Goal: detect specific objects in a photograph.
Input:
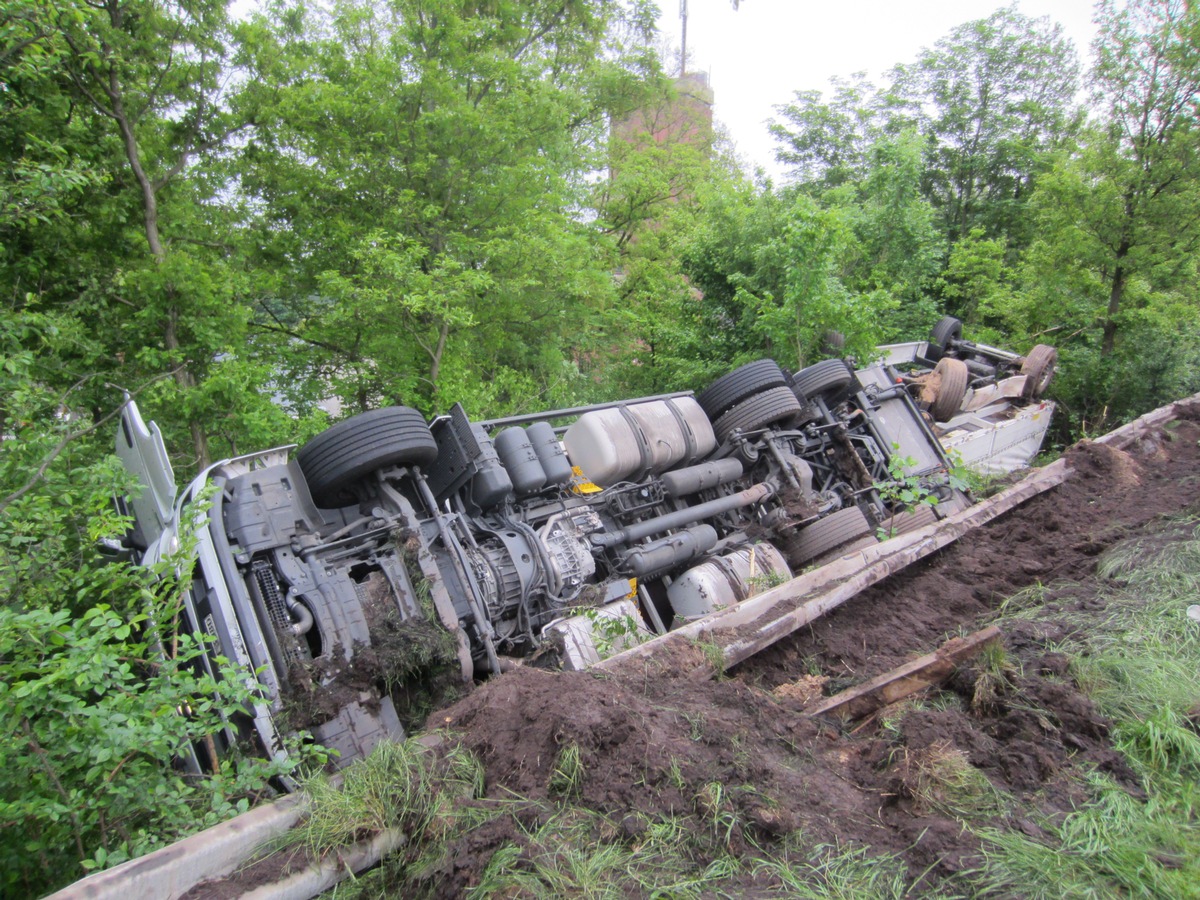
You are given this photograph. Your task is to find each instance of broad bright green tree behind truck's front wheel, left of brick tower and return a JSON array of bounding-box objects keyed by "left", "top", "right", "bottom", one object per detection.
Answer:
[{"left": 242, "top": 0, "right": 662, "bottom": 420}]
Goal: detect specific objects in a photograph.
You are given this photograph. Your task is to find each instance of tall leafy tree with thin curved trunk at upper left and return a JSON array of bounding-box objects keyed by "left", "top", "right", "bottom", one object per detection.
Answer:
[{"left": 0, "top": 0, "right": 295, "bottom": 466}]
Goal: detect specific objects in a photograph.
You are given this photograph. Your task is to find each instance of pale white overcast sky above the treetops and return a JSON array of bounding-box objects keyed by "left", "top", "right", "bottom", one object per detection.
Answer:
[{"left": 659, "top": 0, "right": 1096, "bottom": 181}]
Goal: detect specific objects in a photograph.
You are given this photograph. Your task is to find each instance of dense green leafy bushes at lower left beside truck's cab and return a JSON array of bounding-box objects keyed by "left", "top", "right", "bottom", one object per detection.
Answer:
[{"left": 0, "top": 472, "right": 319, "bottom": 895}]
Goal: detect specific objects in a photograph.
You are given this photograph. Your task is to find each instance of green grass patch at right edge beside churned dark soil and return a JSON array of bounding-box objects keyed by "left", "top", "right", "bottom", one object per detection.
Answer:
[{"left": 973, "top": 520, "right": 1200, "bottom": 900}]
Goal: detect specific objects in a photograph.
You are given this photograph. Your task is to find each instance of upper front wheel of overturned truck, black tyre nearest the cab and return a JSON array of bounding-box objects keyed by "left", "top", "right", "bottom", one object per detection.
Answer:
[{"left": 296, "top": 407, "right": 438, "bottom": 509}]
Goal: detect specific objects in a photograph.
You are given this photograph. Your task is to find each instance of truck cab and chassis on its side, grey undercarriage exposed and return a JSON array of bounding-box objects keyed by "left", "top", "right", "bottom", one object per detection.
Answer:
[{"left": 118, "top": 340, "right": 1051, "bottom": 772}]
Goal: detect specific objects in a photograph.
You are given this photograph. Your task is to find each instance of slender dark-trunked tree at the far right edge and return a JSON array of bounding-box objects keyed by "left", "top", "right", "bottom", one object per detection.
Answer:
[{"left": 1008, "top": 0, "right": 1200, "bottom": 428}]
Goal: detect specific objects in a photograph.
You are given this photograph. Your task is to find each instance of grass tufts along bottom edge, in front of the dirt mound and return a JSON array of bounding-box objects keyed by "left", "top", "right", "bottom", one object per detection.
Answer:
[{"left": 302, "top": 743, "right": 948, "bottom": 900}]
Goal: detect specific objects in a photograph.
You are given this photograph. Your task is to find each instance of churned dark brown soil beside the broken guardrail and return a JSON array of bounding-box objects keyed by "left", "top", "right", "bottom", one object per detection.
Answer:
[{"left": 428, "top": 409, "right": 1200, "bottom": 896}]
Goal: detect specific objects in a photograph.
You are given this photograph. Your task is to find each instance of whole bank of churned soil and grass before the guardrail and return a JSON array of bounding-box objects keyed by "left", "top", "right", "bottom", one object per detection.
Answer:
[{"left": 187, "top": 412, "right": 1200, "bottom": 898}]
